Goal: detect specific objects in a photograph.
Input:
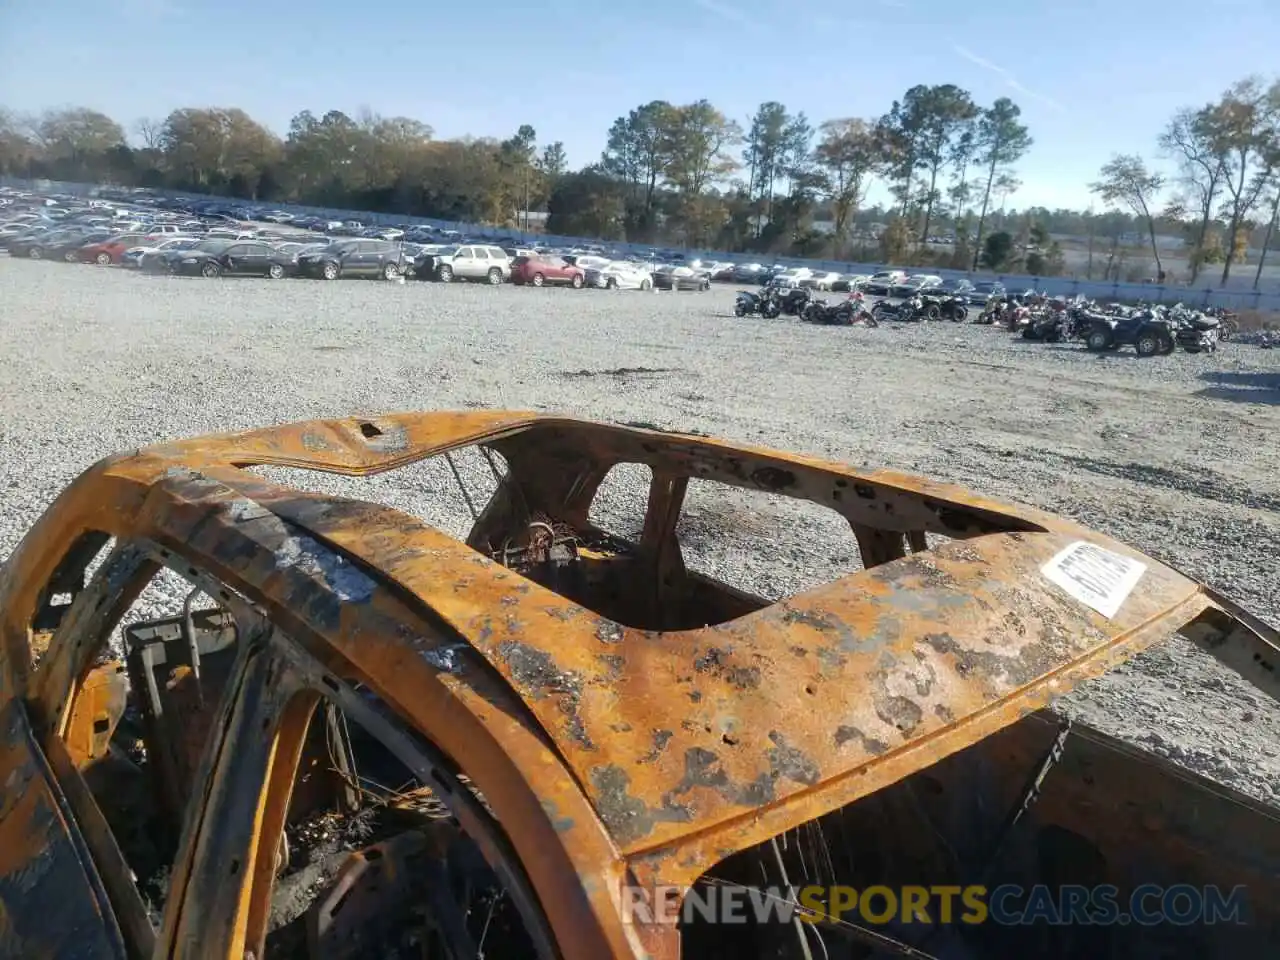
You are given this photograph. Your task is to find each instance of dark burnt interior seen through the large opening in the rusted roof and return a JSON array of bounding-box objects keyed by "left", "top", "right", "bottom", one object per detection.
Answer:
[{"left": 466, "top": 426, "right": 1038, "bottom": 631}]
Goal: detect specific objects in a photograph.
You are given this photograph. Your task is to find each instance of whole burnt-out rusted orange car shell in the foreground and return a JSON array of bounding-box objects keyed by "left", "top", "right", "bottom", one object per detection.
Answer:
[{"left": 0, "top": 412, "right": 1280, "bottom": 960}]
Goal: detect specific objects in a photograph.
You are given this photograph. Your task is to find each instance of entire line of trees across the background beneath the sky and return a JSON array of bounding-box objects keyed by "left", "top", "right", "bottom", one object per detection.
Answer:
[{"left": 0, "top": 77, "right": 1280, "bottom": 280}]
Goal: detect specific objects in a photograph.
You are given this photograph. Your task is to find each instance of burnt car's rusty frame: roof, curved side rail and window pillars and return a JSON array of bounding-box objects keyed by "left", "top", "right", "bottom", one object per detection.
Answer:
[{"left": 0, "top": 412, "right": 1280, "bottom": 960}]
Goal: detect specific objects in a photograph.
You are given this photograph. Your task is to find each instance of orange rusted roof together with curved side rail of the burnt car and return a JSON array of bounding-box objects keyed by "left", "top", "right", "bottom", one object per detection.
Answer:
[{"left": 0, "top": 412, "right": 1269, "bottom": 957}]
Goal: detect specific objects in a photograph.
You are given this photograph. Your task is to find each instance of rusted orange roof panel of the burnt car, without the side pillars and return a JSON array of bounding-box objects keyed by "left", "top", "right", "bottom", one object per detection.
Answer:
[{"left": 0, "top": 412, "right": 1276, "bottom": 906}]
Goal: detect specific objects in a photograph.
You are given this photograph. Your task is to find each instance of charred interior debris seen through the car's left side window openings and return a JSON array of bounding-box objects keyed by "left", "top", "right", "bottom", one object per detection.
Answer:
[{"left": 42, "top": 539, "right": 538, "bottom": 960}]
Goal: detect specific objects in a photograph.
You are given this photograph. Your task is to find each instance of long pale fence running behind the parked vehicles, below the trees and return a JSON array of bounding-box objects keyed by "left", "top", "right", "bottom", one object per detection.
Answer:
[{"left": 0, "top": 177, "right": 1280, "bottom": 312}]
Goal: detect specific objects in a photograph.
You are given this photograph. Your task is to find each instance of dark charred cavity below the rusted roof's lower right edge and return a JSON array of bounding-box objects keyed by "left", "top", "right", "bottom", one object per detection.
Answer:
[{"left": 681, "top": 713, "right": 1280, "bottom": 960}]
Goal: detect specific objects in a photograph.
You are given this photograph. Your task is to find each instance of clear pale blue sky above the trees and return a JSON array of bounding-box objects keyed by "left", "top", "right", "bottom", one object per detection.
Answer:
[{"left": 0, "top": 0, "right": 1280, "bottom": 206}]
